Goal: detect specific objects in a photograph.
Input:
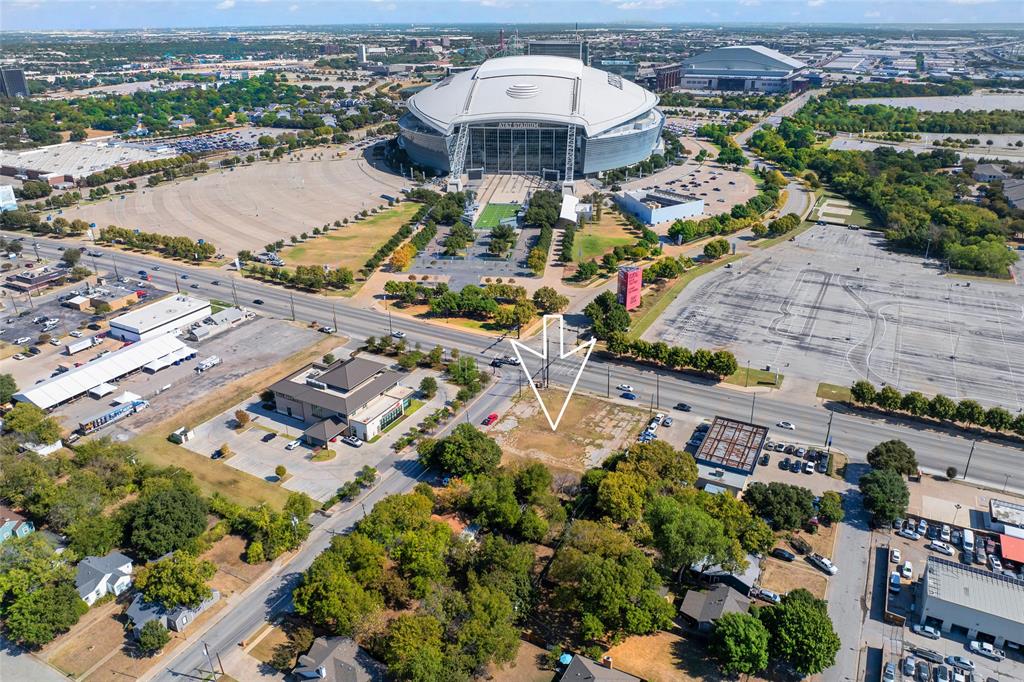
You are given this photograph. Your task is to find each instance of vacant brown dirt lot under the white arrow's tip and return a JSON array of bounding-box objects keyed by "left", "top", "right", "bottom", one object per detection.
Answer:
[{"left": 489, "top": 386, "right": 645, "bottom": 473}]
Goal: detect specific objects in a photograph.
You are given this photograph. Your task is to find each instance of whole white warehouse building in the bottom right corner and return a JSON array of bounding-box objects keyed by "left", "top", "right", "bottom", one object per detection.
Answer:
[{"left": 919, "top": 556, "right": 1024, "bottom": 648}]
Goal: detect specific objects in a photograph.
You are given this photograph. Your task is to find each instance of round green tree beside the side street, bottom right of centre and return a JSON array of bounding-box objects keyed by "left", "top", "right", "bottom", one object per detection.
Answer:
[{"left": 757, "top": 588, "right": 842, "bottom": 675}]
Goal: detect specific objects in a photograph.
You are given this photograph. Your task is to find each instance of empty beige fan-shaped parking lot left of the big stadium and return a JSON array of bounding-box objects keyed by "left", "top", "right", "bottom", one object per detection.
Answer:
[{"left": 65, "top": 147, "right": 410, "bottom": 255}]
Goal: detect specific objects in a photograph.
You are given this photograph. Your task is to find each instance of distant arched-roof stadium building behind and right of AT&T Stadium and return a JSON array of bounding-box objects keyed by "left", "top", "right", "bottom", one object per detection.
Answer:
[{"left": 680, "top": 45, "right": 807, "bottom": 92}]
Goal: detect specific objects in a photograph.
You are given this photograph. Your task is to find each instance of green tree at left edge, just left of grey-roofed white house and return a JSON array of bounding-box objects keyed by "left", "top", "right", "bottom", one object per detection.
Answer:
[{"left": 4, "top": 580, "right": 89, "bottom": 648}]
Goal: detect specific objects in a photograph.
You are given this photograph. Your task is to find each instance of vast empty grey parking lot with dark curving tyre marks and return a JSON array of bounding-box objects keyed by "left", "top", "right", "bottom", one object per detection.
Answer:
[{"left": 645, "top": 226, "right": 1024, "bottom": 412}]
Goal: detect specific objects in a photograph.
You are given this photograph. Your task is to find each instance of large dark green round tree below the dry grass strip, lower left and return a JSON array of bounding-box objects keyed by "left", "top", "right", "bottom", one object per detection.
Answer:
[{"left": 122, "top": 487, "right": 206, "bottom": 558}]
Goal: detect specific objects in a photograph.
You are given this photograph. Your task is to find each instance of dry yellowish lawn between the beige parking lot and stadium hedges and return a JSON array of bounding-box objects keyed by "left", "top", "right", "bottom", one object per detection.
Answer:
[{"left": 282, "top": 202, "right": 420, "bottom": 271}]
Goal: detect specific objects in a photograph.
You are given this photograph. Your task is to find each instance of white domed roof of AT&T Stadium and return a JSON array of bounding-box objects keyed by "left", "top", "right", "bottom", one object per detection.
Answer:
[{"left": 409, "top": 55, "right": 657, "bottom": 137}]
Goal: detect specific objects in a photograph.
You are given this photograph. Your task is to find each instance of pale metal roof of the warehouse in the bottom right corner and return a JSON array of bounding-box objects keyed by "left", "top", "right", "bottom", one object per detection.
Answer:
[{"left": 925, "top": 557, "right": 1024, "bottom": 623}]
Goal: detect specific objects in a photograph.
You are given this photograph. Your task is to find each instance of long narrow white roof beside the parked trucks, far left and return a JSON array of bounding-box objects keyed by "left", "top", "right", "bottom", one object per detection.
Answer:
[{"left": 14, "top": 334, "right": 192, "bottom": 410}]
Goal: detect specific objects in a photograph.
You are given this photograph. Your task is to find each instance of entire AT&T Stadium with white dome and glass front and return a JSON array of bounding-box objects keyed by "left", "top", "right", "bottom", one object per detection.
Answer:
[{"left": 398, "top": 56, "right": 665, "bottom": 182}]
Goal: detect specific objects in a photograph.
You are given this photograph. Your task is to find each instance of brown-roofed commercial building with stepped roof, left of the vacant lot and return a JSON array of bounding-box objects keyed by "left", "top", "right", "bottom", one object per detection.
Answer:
[{"left": 270, "top": 356, "right": 413, "bottom": 445}]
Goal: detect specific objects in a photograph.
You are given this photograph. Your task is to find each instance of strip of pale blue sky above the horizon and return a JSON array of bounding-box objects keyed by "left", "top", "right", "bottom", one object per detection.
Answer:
[{"left": 0, "top": 0, "right": 1024, "bottom": 31}]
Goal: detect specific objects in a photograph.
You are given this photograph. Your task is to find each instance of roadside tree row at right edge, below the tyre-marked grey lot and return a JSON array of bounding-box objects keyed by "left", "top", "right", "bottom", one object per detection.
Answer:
[{"left": 850, "top": 380, "right": 1024, "bottom": 436}]
